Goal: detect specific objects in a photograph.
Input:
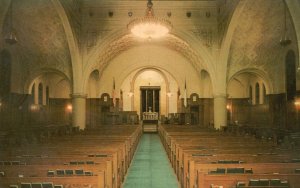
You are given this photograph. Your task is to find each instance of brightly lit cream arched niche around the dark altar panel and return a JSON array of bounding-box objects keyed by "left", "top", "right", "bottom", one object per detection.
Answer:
[{"left": 116, "top": 66, "right": 180, "bottom": 115}]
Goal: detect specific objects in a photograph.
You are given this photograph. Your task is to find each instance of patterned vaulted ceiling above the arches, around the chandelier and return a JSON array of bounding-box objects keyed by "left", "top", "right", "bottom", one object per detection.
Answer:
[{"left": 0, "top": 0, "right": 296, "bottom": 93}]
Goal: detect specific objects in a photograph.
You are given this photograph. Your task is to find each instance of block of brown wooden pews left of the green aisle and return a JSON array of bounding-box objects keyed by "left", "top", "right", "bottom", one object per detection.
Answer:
[{"left": 0, "top": 125, "right": 142, "bottom": 188}]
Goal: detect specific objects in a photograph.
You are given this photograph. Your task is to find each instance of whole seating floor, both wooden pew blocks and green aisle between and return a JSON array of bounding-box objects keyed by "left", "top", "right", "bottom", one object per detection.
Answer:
[{"left": 0, "top": 124, "right": 300, "bottom": 188}]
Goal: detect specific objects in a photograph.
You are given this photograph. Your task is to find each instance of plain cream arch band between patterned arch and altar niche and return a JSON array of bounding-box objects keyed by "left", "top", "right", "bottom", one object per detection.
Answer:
[{"left": 84, "top": 44, "right": 200, "bottom": 97}]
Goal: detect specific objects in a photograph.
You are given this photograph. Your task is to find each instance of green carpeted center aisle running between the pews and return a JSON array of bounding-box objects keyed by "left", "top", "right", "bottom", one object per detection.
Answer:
[{"left": 123, "top": 134, "right": 179, "bottom": 188}]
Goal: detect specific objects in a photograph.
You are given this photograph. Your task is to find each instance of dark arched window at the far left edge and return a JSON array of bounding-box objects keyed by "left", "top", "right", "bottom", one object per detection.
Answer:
[{"left": 0, "top": 50, "right": 11, "bottom": 99}]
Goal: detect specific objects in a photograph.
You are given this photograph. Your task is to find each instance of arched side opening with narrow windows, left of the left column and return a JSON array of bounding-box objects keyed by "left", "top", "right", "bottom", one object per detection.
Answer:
[{"left": 28, "top": 72, "right": 72, "bottom": 125}]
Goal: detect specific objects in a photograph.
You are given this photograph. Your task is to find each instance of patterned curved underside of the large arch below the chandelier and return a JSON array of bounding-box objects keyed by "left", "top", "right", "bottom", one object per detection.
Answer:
[{"left": 84, "top": 30, "right": 215, "bottom": 90}]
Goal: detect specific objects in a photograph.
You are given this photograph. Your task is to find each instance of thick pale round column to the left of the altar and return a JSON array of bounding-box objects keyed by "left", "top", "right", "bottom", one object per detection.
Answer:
[{"left": 72, "top": 93, "right": 87, "bottom": 130}]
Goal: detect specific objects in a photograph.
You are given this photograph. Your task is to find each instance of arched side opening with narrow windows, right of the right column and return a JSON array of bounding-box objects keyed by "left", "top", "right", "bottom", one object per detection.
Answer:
[{"left": 227, "top": 70, "right": 270, "bottom": 126}]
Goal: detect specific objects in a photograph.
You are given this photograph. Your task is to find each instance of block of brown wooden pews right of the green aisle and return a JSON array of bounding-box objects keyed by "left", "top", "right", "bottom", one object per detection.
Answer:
[{"left": 158, "top": 125, "right": 300, "bottom": 188}]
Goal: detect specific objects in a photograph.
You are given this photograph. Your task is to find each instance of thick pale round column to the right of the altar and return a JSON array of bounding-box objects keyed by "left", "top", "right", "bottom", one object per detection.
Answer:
[{"left": 214, "top": 94, "right": 227, "bottom": 130}]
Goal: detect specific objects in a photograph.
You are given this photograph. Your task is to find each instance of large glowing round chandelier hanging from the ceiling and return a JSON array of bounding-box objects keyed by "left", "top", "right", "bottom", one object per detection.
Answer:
[{"left": 127, "top": 0, "right": 172, "bottom": 40}]
